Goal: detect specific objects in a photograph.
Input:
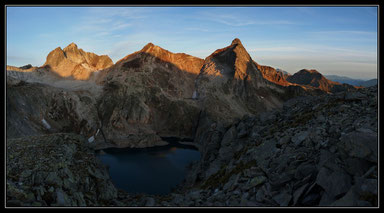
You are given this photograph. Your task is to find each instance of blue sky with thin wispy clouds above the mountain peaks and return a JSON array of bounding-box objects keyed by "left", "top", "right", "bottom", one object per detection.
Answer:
[{"left": 6, "top": 7, "right": 378, "bottom": 79}]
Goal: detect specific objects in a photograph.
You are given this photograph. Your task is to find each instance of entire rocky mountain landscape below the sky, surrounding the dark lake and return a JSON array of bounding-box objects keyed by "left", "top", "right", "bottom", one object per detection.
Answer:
[{"left": 6, "top": 39, "right": 379, "bottom": 207}]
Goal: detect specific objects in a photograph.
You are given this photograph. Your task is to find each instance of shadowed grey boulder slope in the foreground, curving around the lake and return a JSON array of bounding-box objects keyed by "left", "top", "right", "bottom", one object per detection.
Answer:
[{"left": 7, "top": 86, "right": 378, "bottom": 206}]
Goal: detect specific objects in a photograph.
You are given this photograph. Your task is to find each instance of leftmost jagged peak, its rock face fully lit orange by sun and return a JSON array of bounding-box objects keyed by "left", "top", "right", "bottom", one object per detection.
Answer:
[{"left": 43, "top": 43, "right": 113, "bottom": 80}]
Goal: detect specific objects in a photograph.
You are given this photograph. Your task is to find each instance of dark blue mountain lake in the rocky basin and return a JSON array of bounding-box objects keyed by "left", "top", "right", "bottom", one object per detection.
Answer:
[{"left": 97, "top": 142, "right": 200, "bottom": 194}]
